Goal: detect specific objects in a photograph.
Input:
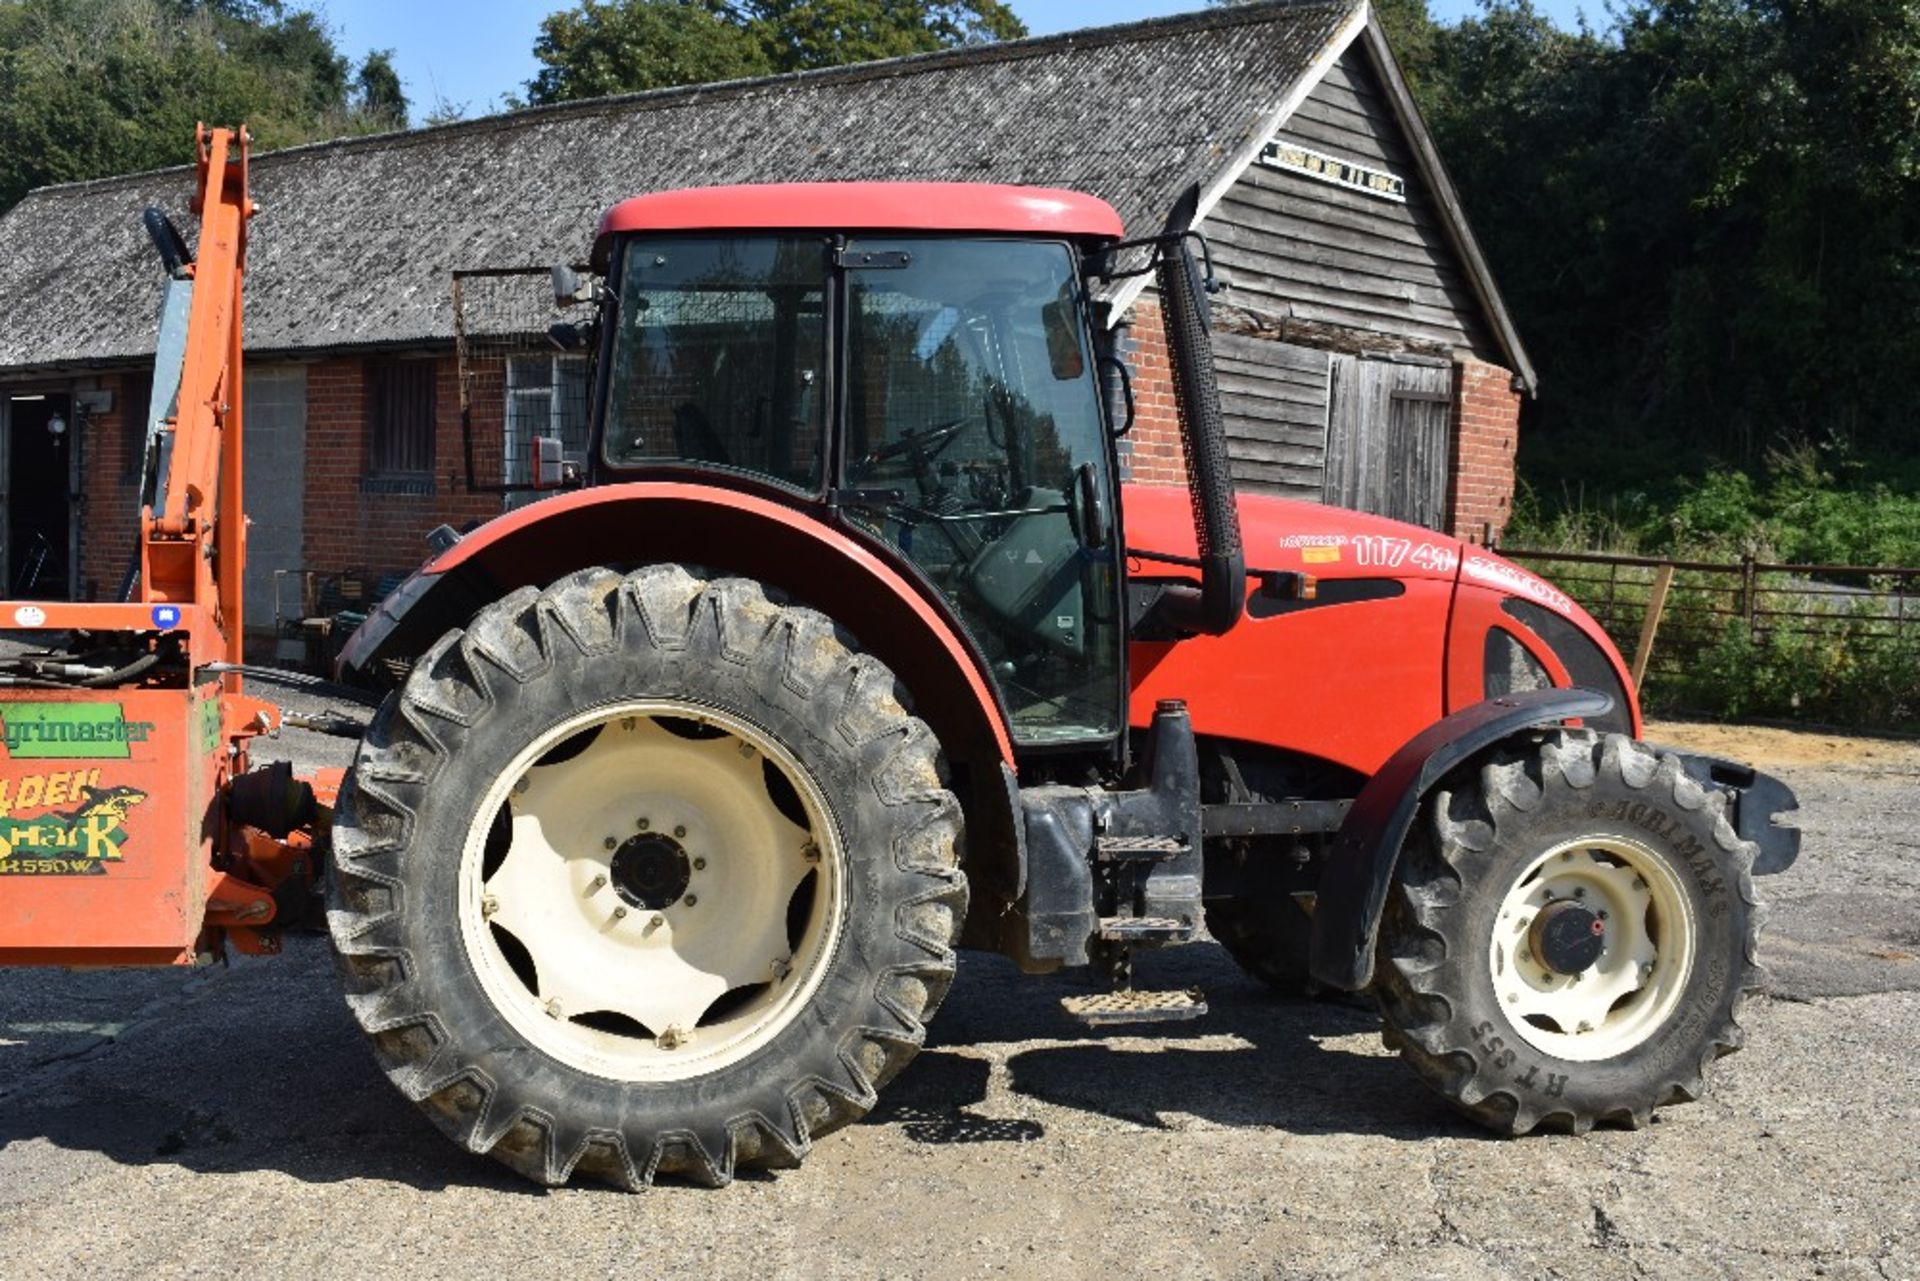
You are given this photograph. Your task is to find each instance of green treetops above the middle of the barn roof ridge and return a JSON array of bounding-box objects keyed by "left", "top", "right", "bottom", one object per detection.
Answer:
[{"left": 526, "top": 0, "right": 1027, "bottom": 104}]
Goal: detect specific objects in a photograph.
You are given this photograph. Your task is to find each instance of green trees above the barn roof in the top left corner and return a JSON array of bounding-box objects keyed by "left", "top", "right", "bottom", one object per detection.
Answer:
[{"left": 0, "top": 0, "right": 407, "bottom": 211}]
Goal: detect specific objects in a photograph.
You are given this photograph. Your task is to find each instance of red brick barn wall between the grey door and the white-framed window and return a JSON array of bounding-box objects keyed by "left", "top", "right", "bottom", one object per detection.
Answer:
[{"left": 301, "top": 347, "right": 501, "bottom": 574}]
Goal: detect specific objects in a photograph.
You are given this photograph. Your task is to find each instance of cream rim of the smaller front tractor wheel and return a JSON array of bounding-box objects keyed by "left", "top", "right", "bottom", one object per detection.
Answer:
[{"left": 1488, "top": 835, "right": 1697, "bottom": 1062}]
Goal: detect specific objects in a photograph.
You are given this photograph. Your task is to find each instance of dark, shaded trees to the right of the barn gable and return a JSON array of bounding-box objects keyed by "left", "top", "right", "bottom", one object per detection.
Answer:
[{"left": 1423, "top": 0, "right": 1920, "bottom": 492}]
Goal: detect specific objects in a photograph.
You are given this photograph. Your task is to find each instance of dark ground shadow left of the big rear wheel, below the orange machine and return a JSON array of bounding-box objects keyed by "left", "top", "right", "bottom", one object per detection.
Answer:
[{"left": 0, "top": 939, "right": 541, "bottom": 1196}]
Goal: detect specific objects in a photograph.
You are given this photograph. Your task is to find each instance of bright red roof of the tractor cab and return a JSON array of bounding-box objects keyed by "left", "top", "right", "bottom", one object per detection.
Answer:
[{"left": 593, "top": 182, "right": 1125, "bottom": 265}]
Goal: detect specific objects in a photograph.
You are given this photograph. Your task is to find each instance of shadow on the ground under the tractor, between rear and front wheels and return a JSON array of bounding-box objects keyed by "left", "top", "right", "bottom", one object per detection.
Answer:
[{"left": 868, "top": 945, "right": 1486, "bottom": 1145}]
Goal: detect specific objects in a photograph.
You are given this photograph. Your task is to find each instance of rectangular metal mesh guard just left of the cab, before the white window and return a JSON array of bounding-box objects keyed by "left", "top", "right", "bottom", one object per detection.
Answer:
[{"left": 453, "top": 267, "right": 591, "bottom": 507}]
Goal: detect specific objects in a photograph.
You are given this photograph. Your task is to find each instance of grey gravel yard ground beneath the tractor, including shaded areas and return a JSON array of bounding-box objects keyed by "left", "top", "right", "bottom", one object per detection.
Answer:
[{"left": 0, "top": 706, "right": 1920, "bottom": 1279}]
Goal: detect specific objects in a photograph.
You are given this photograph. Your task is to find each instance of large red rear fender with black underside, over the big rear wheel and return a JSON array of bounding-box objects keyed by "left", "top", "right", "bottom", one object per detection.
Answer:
[{"left": 340, "top": 480, "right": 1014, "bottom": 810}]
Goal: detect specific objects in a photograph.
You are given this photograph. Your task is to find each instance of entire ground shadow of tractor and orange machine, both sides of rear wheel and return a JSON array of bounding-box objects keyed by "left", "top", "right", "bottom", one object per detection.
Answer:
[{"left": 0, "top": 939, "right": 1478, "bottom": 1196}]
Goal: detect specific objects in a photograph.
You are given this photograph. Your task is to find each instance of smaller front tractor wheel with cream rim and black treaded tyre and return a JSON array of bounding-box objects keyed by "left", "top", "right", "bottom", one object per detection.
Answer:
[{"left": 1377, "top": 730, "right": 1763, "bottom": 1135}]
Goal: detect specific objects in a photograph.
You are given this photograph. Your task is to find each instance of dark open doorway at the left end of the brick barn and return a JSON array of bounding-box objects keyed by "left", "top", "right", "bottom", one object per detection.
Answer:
[{"left": 0, "top": 392, "right": 75, "bottom": 601}]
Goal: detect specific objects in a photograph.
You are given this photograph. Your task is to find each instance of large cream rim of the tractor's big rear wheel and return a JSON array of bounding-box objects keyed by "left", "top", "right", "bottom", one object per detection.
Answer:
[{"left": 459, "top": 699, "right": 845, "bottom": 1081}]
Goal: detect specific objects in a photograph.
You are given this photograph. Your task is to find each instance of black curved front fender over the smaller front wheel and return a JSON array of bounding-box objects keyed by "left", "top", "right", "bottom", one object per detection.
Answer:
[{"left": 1309, "top": 689, "right": 1613, "bottom": 991}]
